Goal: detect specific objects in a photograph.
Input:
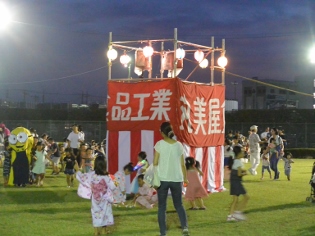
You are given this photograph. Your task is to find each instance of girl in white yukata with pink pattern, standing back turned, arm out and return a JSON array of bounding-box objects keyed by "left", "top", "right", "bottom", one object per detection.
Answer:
[{"left": 74, "top": 156, "right": 115, "bottom": 235}]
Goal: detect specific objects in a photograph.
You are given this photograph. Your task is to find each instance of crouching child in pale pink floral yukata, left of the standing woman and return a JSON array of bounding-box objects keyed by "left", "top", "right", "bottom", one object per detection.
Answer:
[{"left": 135, "top": 175, "right": 158, "bottom": 209}]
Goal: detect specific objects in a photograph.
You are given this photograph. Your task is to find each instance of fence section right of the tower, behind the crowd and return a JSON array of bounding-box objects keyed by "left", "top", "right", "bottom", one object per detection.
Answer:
[{"left": 225, "top": 122, "right": 315, "bottom": 148}]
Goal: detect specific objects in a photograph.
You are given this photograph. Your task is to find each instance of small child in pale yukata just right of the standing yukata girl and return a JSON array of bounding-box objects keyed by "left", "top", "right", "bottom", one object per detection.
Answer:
[{"left": 113, "top": 162, "right": 133, "bottom": 205}]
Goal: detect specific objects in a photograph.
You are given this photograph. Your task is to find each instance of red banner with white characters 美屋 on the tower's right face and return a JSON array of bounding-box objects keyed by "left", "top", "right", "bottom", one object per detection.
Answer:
[{"left": 173, "top": 80, "right": 225, "bottom": 147}]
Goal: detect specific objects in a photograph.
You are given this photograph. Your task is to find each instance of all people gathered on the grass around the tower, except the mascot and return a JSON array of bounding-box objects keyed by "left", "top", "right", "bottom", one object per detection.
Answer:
[{"left": 0, "top": 122, "right": 293, "bottom": 235}]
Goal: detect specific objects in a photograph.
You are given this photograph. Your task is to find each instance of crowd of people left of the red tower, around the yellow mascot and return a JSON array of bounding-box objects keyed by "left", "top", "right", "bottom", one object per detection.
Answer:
[{"left": 0, "top": 123, "right": 105, "bottom": 188}]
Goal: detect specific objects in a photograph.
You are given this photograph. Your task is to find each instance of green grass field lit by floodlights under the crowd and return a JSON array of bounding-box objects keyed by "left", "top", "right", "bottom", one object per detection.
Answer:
[{"left": 0, "top": 159, "right": 315, "bottom": 236}]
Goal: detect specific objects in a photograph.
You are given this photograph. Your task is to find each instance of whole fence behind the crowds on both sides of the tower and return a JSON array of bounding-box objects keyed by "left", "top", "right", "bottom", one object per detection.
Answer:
[{"left": 3, "top": 120, "right": 315, "bottom": 148}]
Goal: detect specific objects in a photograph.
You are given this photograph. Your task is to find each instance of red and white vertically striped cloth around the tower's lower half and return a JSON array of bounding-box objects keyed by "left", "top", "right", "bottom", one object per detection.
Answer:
[{"left": 106, "top": 130, "right": 224, "bottom": 192}]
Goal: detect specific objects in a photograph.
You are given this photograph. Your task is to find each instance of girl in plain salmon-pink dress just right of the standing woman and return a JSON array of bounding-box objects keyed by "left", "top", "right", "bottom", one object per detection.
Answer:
[{"left": 185, "top": 157, "right": 208, "bottom": 210}]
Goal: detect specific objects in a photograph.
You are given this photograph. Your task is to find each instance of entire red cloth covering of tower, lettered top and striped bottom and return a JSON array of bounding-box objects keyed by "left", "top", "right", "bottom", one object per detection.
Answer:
[{"left": 106, "top": 78, "right": 225, "bottom": 192}]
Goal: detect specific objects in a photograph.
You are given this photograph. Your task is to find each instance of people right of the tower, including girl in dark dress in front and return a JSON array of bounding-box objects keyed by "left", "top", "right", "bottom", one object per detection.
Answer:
[{"left": 224, "top": 125, "right": 294, "bottom": 221}]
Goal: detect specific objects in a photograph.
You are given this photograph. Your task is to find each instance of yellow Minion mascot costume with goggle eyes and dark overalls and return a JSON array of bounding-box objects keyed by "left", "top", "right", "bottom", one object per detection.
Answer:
[{"left": 8, "top": 127, "right": 34, "bottom": 187}]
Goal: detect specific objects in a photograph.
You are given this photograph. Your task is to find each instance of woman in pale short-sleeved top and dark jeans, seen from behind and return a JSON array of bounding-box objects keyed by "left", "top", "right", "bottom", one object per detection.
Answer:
[{"left": 153, "top": 122, "right": 189, "bottom": 235}]
